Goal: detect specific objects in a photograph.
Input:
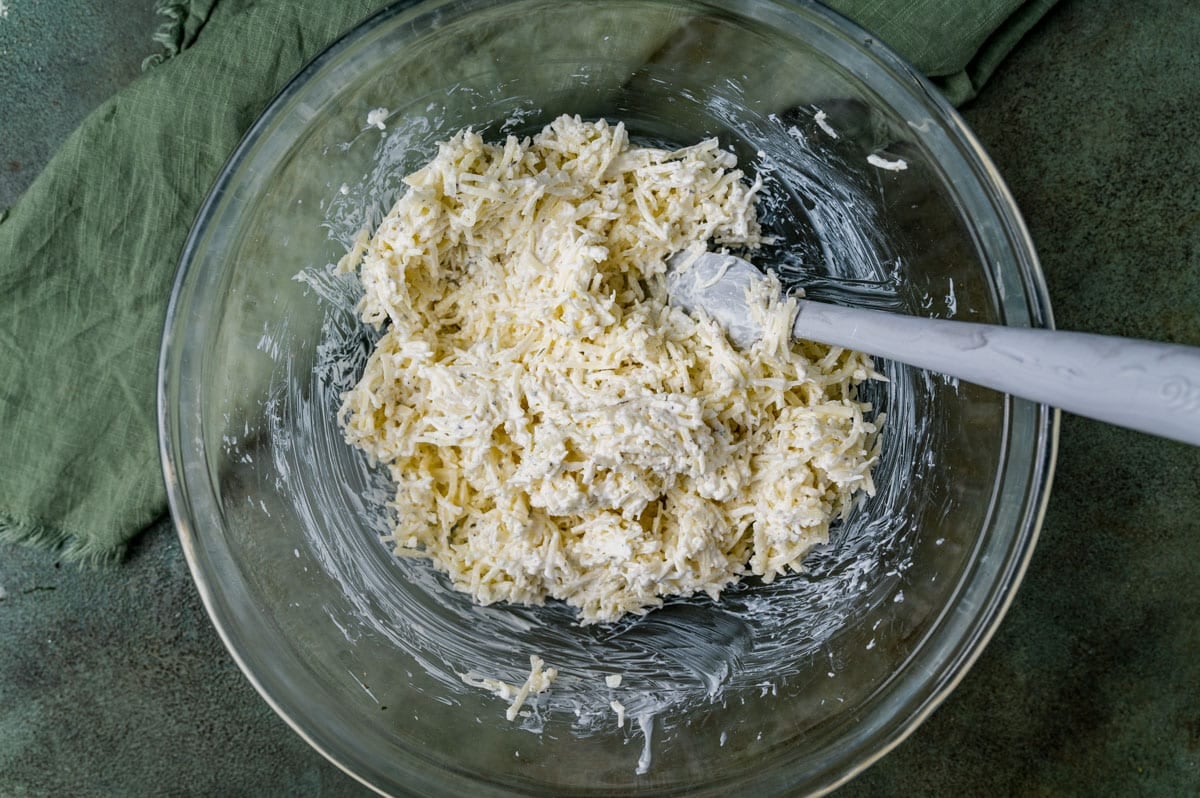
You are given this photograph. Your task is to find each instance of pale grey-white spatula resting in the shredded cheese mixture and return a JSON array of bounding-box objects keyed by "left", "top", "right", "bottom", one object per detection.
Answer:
[{"left": 667, "top": 252, "right": 1200, "bottom": 445}]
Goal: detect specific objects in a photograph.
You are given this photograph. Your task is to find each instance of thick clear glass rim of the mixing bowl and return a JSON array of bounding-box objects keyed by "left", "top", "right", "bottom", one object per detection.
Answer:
[{"left": 156, "top": 0, "right": 1061, "bottom": 794}]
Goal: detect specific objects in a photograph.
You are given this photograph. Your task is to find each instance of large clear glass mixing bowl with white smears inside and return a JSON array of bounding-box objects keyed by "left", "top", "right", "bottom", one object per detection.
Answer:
[{"left": 158, "top": 0, "right": 1056, "bottom": 796}]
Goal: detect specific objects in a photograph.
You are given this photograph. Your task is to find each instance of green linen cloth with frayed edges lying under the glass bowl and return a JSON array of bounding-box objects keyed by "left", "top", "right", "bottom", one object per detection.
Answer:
[{"left": 0, "top": 0, "right": 1054, "bottom": 563}]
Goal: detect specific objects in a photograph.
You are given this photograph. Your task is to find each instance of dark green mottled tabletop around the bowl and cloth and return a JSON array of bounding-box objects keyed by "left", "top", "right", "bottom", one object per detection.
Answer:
[{"left": 0, "top": 0, "right": 1200, "bottom": 797}]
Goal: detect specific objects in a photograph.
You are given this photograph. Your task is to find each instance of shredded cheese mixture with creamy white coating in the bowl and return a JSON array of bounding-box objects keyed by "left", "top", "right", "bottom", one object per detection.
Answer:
[{"left": 340, "top": 116, "right": 877, "bottom": 623}]
